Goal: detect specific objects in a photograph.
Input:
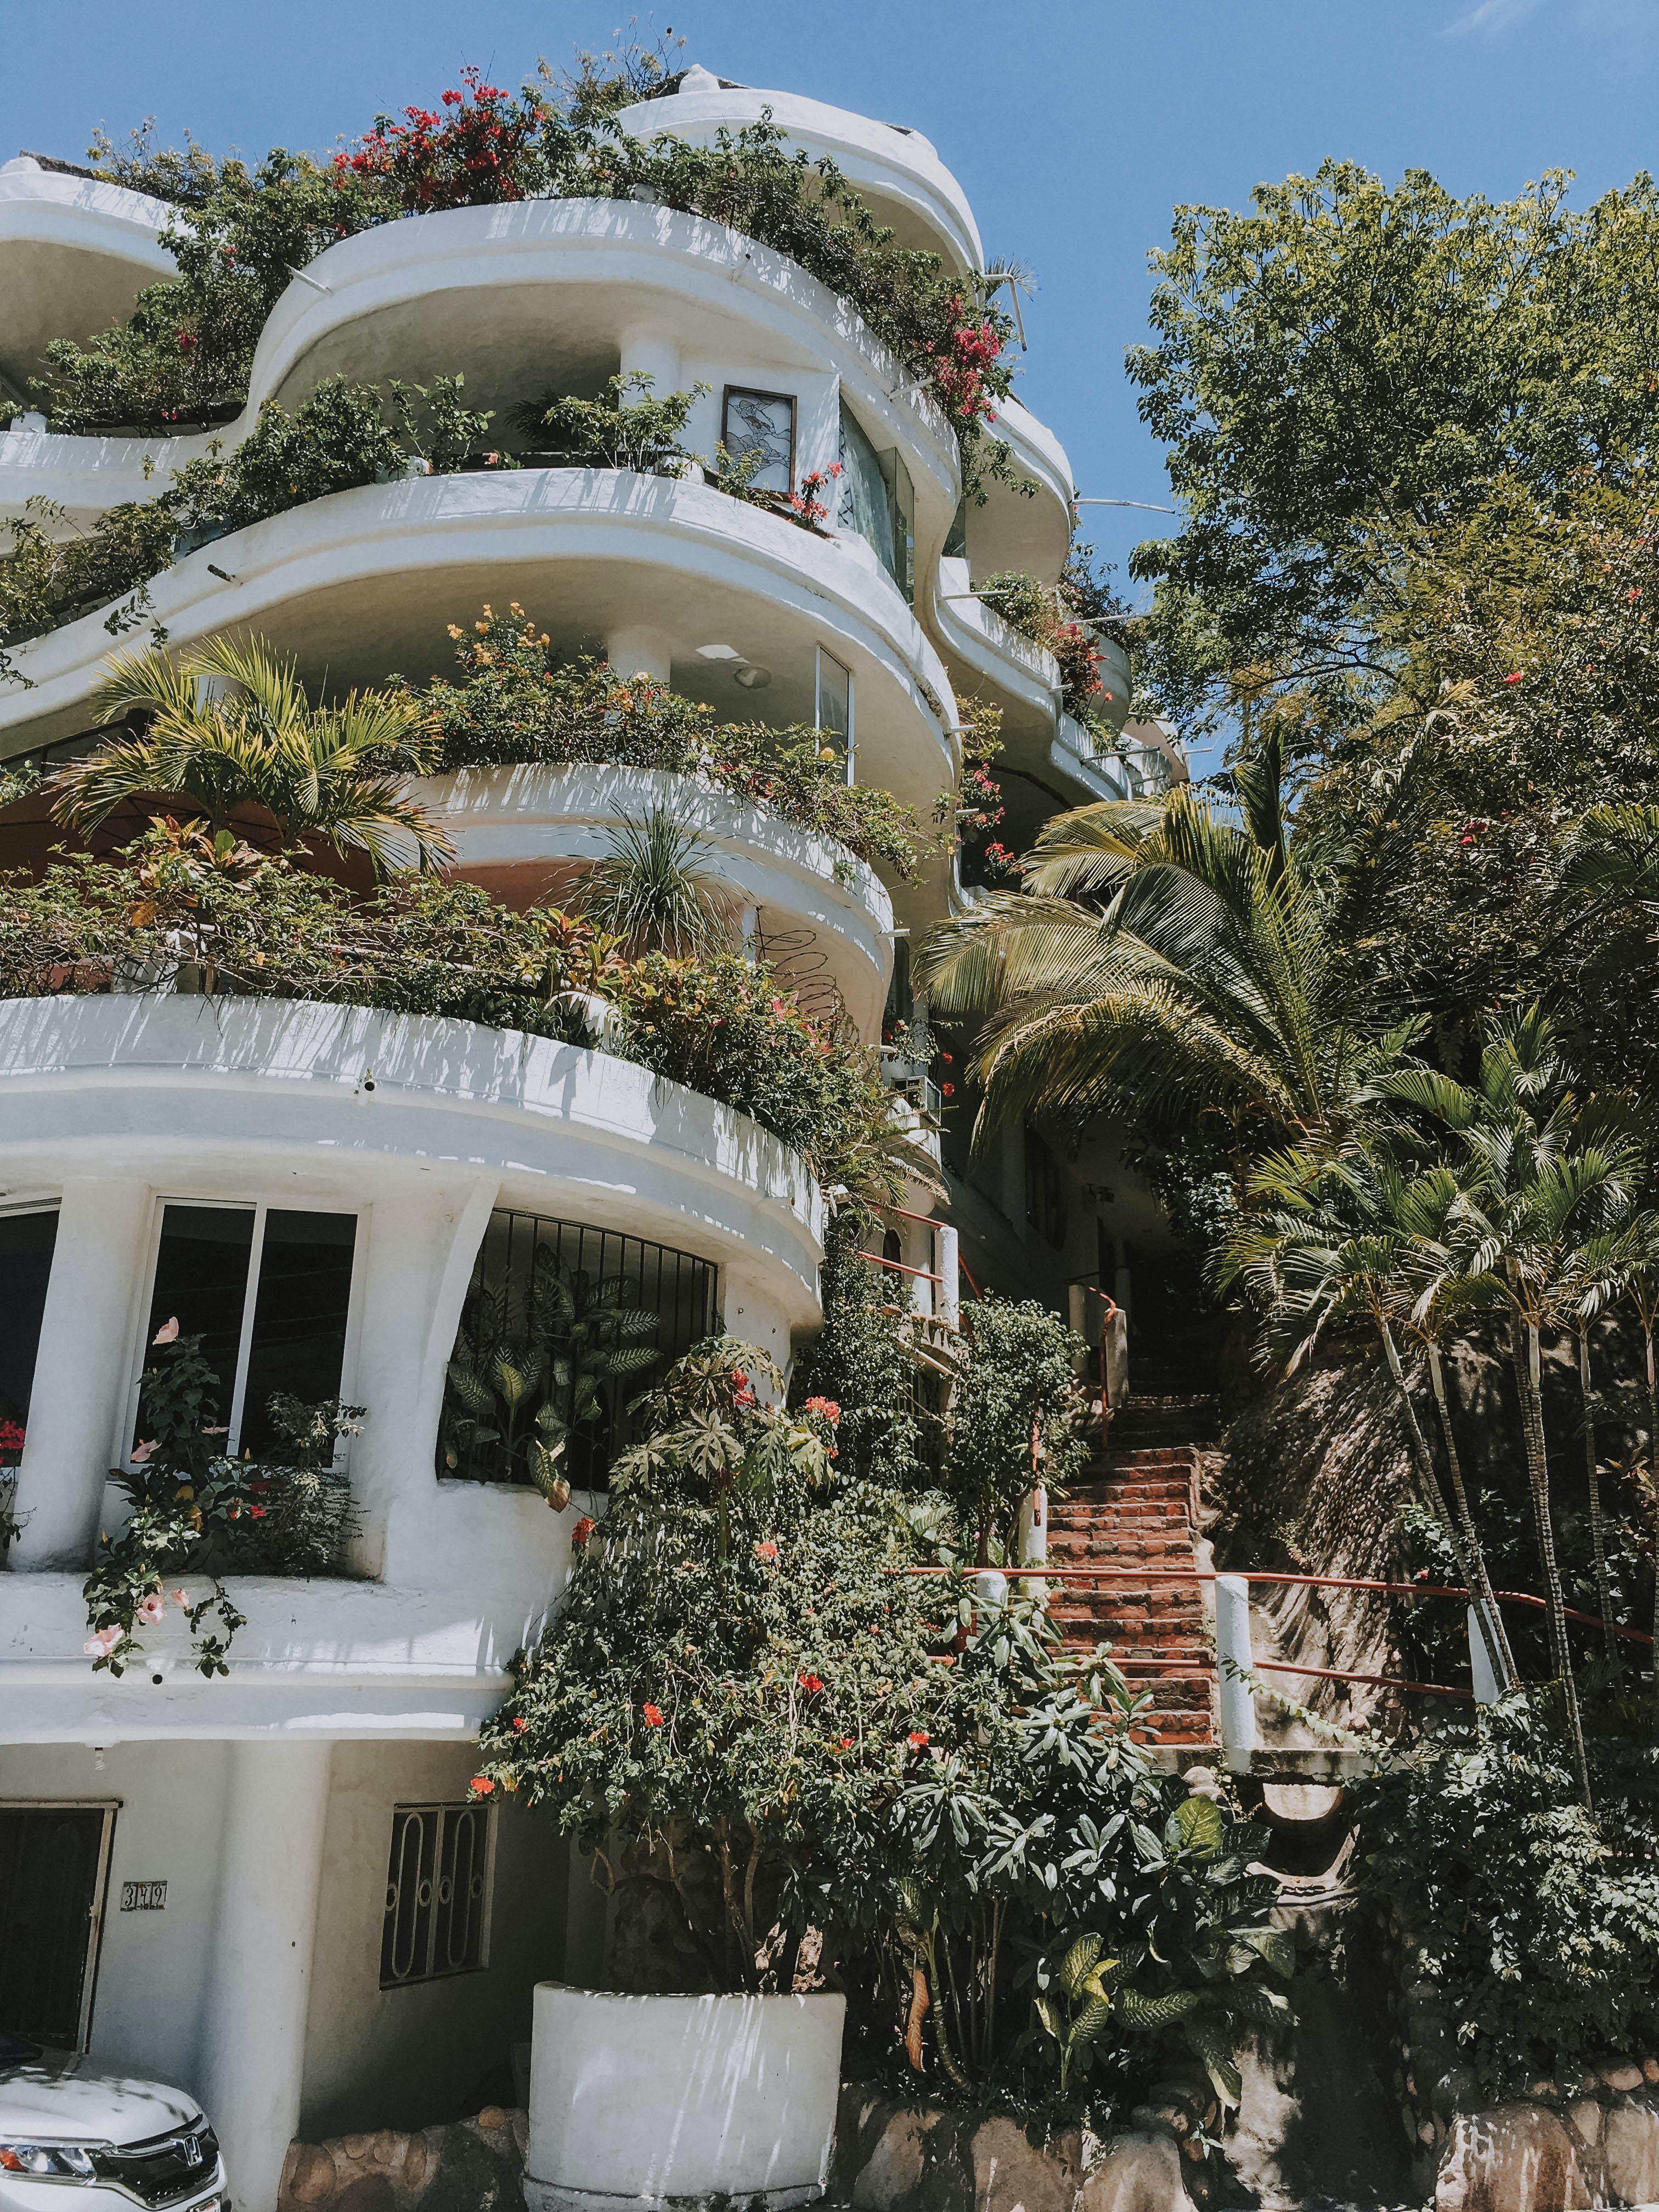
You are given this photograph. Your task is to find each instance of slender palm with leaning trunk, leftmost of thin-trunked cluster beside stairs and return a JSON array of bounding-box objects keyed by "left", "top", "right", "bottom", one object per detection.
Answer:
[{"left": 1223, "top": 1146, "right": 1520, "bottom": 1692}]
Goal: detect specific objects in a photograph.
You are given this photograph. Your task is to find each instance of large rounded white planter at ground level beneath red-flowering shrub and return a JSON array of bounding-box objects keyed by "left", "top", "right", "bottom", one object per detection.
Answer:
[{"left": 524, "top": 1982, "right": 847, "bottom": 2212}]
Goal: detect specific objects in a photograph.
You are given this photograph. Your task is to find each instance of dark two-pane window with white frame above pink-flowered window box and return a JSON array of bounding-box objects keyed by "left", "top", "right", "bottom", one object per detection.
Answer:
[{"left": 139, "top": 1201, "right": 356, "bottom": 1458}]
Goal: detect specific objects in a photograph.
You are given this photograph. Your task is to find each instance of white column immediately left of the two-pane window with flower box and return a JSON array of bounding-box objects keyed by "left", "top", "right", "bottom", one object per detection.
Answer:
[{"left": 9, "top": 1177, "right": 153, "bottom": 1573}]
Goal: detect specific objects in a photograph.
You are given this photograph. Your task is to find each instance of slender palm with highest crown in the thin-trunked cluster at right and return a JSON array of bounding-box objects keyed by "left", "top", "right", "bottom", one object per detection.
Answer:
[{"left": 1380, "top": 1007, "right": 1637, "bottom": 1807}]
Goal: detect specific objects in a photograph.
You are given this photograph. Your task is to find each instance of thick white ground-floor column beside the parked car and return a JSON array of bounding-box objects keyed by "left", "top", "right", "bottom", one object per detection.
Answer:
[{"left": 197, "top": 1741, "right": 332, "bottom": 2212}]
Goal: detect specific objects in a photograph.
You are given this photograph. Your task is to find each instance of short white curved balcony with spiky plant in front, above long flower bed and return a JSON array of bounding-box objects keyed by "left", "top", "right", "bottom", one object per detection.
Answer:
[{"left": 414, "top": 763, "right": 894, "bottom": 1037}]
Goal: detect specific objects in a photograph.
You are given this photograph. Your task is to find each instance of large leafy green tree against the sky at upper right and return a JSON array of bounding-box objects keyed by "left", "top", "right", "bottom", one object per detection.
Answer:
[{"left": 1128, "top": 161, "right": 1659, "bottom": 738}]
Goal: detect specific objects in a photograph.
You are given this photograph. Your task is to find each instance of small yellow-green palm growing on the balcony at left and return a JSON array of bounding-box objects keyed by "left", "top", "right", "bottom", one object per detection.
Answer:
[{"left": 51, "top": 637, "right": 454, "bottom": 872}]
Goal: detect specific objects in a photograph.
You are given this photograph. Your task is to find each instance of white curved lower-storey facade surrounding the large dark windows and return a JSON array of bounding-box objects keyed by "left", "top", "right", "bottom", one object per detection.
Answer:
[{"left": 0, "top": 995, "right": 823, "bottom": 1743}]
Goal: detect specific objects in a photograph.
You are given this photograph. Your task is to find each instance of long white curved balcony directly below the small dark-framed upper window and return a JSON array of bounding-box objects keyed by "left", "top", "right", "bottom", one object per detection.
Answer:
[{"left": 0, "top": 469, "right": 956, "bottom": 819}]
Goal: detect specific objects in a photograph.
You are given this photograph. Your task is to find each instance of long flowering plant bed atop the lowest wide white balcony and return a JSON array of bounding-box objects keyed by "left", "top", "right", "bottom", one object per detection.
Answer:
[{"left": 0, "top": 821, "right": 924, "bottom": 1194}]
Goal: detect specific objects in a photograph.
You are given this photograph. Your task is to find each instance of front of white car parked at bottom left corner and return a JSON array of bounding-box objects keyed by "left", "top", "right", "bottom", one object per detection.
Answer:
[{"left": 0, "top": 2028, "right": 225, "bottom": 2212}]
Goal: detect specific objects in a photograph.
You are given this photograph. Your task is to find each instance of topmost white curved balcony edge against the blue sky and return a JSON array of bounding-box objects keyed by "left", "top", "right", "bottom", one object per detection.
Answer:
[{"left": 617, "top": 69, "right": 984, "bottom": 274}]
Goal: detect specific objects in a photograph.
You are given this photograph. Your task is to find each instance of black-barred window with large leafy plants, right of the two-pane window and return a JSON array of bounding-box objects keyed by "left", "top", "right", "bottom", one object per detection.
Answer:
[{"left": 438, "top": 1207, "right": 716, "bottom": 1491}]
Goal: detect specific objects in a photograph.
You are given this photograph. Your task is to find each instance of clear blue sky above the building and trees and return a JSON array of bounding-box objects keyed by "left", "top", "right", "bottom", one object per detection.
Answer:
[{"left": 0, "top": 0, "right": 1659, "bottom": 633}]
